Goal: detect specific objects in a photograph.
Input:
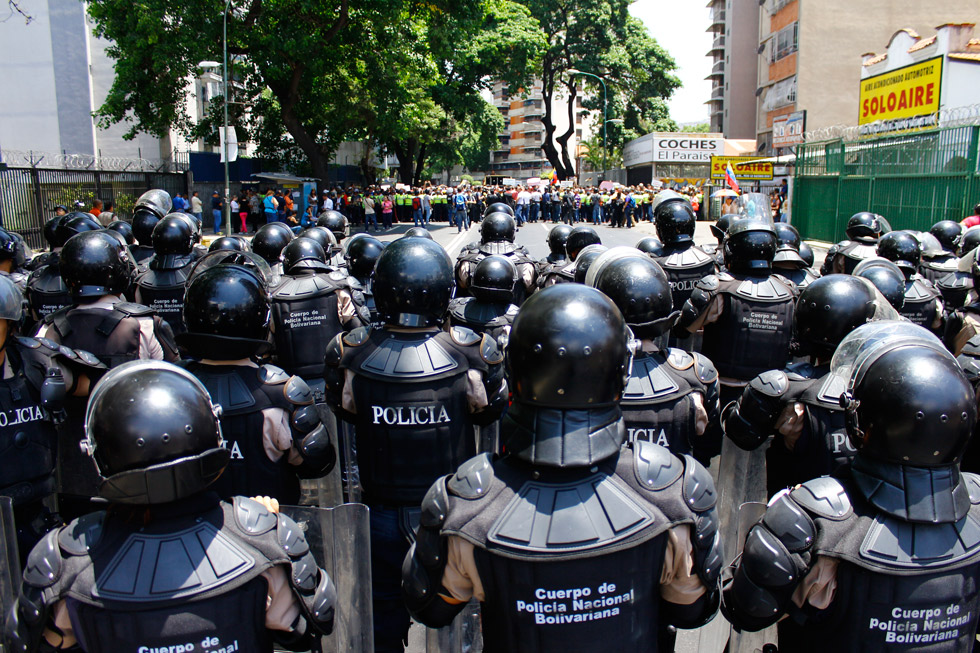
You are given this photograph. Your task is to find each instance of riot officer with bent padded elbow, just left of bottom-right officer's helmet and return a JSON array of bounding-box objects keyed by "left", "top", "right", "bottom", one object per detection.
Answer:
[{"left": 722, "top": 274, "right": 898, "bottom": 496}]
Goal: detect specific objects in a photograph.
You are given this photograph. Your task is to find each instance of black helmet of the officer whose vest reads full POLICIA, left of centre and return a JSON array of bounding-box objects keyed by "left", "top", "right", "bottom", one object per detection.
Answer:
[{"left": 372, "top": 238, "right": 454, "bottom": 327}]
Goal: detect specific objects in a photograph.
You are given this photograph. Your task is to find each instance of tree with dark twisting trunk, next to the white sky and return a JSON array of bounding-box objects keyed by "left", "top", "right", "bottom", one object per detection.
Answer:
[{"left": 523, "top": 0, "right": 680, "bottom": 179}]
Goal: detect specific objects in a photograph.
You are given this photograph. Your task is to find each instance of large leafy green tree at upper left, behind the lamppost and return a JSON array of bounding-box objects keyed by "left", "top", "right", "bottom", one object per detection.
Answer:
[{"left": 88, "top": 0, "right": 540, "bottom": 190}]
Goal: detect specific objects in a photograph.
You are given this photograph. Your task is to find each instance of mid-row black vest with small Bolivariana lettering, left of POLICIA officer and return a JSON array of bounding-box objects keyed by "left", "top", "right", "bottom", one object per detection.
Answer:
[{"left": 272, "top": 273, "right": 347, "bottom": 379}]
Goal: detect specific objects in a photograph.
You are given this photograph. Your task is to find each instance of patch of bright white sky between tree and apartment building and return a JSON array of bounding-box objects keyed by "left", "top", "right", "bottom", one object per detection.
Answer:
[{"left": 630, "top": 0, "right": 711, "bottom": 124}]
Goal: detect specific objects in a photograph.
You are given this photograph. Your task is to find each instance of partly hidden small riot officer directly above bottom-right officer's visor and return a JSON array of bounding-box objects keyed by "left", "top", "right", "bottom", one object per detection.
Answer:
[{"left": 878, "top": 231, "right": 945, "bottom": 336}]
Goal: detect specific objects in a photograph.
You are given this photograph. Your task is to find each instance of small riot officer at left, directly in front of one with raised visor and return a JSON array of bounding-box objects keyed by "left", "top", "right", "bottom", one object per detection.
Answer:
[{"left": 136, "top": 214, "right": 196, "bottom": 334}]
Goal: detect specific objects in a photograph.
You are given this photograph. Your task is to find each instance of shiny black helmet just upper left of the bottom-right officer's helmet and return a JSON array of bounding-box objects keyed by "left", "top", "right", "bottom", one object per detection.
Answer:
[{"left": 793, "top": 274, "right": 883, "bottom": 357}]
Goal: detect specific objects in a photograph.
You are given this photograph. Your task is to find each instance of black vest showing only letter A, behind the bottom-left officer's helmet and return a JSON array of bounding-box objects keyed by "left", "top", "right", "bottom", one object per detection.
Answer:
[{"left": 181, "top": 361, "right": 300, "bottom": 505}]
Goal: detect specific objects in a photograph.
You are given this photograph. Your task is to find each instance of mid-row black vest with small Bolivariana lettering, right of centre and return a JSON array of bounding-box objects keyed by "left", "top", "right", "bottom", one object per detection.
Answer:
[{"left": 701, "top": 273, "right": 796, "bottom": 381}]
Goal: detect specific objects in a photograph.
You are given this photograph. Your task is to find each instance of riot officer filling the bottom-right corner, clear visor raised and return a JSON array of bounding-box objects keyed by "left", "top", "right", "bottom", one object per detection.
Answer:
[{"left": 723, "top": 322, "right": 980, "bottom": 651}]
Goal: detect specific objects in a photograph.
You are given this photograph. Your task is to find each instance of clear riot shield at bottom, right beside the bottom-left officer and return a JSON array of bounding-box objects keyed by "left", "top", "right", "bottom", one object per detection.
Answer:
[{"left": 279, "top": 503, "right": 374, "bottom": 653}]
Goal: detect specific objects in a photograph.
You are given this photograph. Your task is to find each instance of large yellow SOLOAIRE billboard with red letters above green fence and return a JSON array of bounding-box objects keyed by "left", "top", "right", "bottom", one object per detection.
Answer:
[{"left": 858, "top": 57, "right": 943, "bottom": 134}]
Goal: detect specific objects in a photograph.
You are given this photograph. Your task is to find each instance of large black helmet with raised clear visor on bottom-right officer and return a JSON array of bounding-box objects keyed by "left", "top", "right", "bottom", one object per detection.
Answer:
[{"left": 832, "top": 336, "right": 977, "bottom": 467}]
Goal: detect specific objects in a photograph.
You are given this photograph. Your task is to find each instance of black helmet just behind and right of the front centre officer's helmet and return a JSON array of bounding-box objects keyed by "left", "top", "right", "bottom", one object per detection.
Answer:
[{"left": 595, "top": 256, "right": 680, "bottom": 339}]
